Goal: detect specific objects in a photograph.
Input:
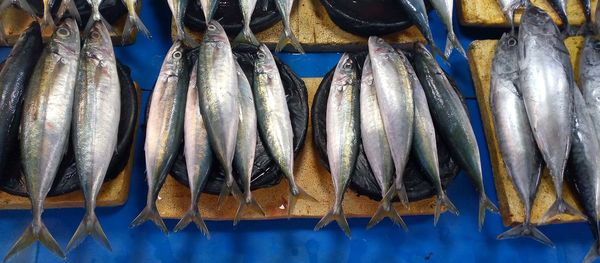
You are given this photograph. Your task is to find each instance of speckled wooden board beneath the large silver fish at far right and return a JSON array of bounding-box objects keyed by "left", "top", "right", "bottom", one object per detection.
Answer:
[{"left": 468, "top": 37, "right": 583, "bottom": 226}]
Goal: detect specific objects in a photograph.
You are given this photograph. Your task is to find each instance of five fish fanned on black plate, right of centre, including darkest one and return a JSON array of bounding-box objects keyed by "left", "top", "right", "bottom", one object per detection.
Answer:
[{"left": 315, "top": 37, "right": 497, "bottom": 236}]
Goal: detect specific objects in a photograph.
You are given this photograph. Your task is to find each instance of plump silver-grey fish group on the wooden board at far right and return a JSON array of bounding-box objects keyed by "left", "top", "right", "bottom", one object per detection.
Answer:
[{"left": 490, "top": 6, "right": 600, "bottom": 262}]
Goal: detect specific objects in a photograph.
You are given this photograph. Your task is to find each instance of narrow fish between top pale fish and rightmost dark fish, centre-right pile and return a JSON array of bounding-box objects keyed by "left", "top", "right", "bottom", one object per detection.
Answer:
[{"left": 405, "top": 50, "right": 459, "bottom": 225}]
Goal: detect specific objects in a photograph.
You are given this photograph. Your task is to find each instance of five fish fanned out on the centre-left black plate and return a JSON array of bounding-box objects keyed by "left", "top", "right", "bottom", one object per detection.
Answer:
[{"left": 131, "top": 20, "right": 314, "bottom": 235}]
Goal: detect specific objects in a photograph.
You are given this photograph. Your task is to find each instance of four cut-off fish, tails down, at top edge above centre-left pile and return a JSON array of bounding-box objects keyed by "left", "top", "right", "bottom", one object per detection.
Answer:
[{"left": 167, "top": 0, "right": 304, "bottom": 53}]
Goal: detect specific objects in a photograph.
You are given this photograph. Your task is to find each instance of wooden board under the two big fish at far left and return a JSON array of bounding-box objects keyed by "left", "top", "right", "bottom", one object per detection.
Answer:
[{"left": 0, "top": 83, "right": 142, "bottom": 210}]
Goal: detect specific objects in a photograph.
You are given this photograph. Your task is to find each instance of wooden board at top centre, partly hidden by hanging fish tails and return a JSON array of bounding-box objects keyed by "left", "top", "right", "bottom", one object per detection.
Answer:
[{"left": 171, "top": 0, "right": 425, "bottom": 52}]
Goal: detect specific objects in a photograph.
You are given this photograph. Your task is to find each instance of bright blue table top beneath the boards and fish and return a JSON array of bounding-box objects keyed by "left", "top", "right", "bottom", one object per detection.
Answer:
[{"left": 0, "top": 0, "right": 593, "bottom": 262}]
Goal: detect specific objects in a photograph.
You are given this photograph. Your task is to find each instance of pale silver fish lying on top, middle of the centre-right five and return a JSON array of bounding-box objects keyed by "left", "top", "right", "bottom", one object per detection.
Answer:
[{"left": 369, "top": 36, "right": 415, "bottom": 206}]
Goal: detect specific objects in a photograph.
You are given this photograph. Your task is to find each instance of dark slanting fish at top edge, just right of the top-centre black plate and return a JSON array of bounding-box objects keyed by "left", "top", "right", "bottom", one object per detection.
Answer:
[{"left": 396, "top": 0, "right": 448, "bottom": 60}]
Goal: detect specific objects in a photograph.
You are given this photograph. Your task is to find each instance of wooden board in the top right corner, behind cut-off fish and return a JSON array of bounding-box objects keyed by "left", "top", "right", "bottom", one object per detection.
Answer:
[{"left": 459, "top": 0, "right": 598, "bottom": 27}]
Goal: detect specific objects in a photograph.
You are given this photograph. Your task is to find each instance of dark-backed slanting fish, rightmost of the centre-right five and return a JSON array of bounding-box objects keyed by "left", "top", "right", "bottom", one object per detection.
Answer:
[{"left": 415, "top": 43, "right": 498, "bottom": 230}]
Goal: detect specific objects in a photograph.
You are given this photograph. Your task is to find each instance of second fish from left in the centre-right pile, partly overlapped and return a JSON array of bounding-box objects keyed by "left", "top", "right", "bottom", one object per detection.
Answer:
[{"left": 359, "top": 55, "right": 407, "bottom": 229}]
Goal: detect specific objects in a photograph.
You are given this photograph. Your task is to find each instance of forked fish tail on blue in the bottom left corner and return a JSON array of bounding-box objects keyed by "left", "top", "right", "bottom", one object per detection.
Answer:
[{"left": 4, "top": 220, "right": 65, "bottom": 261}]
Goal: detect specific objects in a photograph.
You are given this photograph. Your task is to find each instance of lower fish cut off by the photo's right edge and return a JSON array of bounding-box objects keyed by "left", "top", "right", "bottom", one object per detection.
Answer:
[{"left": 568, "top": 88, "right": 600, "bottom": 262}]
